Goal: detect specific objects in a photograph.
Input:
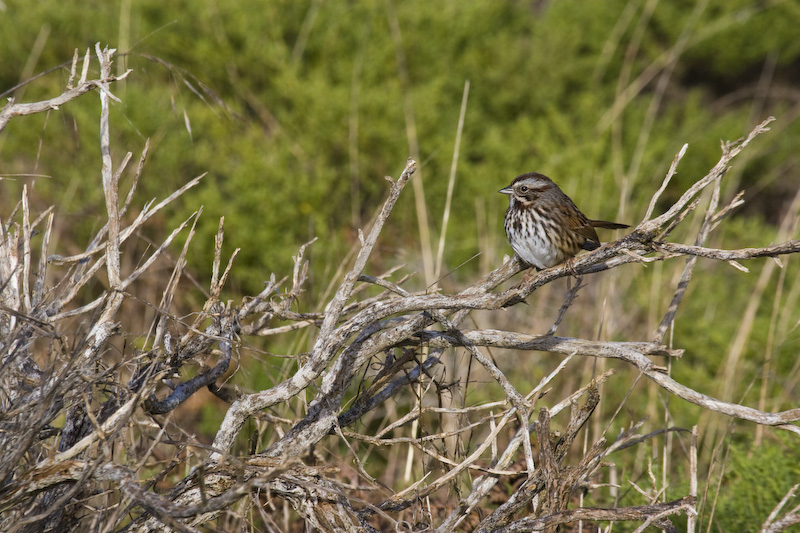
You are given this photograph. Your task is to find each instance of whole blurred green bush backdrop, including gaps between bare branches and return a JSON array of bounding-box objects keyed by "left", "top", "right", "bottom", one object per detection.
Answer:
[{"left": 0, "top": 0, "right": 800, "bottom": 530}]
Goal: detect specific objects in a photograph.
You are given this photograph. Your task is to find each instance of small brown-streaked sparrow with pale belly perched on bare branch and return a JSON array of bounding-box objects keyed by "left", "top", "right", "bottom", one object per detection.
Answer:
[{"left": 498, "top": 172, "right": 628, "bottom": 269}]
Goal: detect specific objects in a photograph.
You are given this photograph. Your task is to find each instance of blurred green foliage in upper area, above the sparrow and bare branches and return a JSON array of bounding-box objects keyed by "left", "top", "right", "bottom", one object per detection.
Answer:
[{"left": 6, "top": 0, "right": 800, "bottom": 292}]
